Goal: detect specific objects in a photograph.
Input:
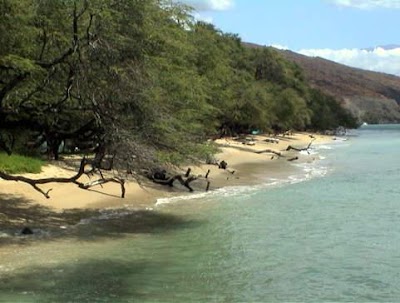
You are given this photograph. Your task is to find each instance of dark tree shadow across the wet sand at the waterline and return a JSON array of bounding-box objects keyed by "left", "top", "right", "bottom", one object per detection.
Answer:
[{"left": 0, "top": 194, "right": 201, "bottom": 246}]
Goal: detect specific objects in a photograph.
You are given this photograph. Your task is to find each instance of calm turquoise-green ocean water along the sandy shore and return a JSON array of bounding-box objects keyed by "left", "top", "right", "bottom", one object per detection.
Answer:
[{"left": 0, "top": 125, "right": 400, "bottom": 302}]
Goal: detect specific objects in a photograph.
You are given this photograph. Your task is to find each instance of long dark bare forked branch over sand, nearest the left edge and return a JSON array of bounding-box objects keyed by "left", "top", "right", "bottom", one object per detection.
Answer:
[{"left": 0, "top": 157, "right": 125, "bottom": 199}]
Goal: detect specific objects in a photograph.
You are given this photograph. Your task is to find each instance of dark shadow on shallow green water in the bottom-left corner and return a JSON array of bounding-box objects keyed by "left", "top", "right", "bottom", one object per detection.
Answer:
[{"left": 0, "top": 259, "right": 155, "bottom": 302}]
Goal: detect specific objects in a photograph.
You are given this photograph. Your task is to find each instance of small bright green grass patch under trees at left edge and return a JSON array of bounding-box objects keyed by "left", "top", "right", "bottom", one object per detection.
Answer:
[{"left": 0, "top": 153, "right": 45, "bottom": 174}]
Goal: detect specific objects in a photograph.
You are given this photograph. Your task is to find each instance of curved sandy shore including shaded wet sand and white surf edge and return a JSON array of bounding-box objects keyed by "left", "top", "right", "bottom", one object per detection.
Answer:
[{"left": 0, "top": 133, "right": 340, "bottom": 270}]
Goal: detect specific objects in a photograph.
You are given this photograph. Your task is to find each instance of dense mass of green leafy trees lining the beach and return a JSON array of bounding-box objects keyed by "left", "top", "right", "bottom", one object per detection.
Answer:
[{"left": 0, "top": 0, "right": 355, "bottom": 171}]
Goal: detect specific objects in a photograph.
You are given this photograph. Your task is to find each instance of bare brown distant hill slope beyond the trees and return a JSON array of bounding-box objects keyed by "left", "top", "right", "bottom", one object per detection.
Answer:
[{"left": 245, "top": 43, "right": 400, "bottom": 123}]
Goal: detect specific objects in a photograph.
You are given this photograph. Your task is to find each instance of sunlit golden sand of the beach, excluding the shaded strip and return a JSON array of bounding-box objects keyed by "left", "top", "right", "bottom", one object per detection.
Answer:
[{"left": 0, "top": 133, "right": 332, "bottom": 211}]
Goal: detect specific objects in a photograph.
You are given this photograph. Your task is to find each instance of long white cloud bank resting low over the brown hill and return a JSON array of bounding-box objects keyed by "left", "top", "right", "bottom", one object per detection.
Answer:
[{"left": 298, "top": 47, "right": 400, "bottom": 76}]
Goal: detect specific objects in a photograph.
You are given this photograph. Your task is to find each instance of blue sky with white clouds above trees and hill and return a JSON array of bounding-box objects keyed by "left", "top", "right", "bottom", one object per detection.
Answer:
[{"left": 179, "top": 0, "right": 400, "bottom": 76}]
